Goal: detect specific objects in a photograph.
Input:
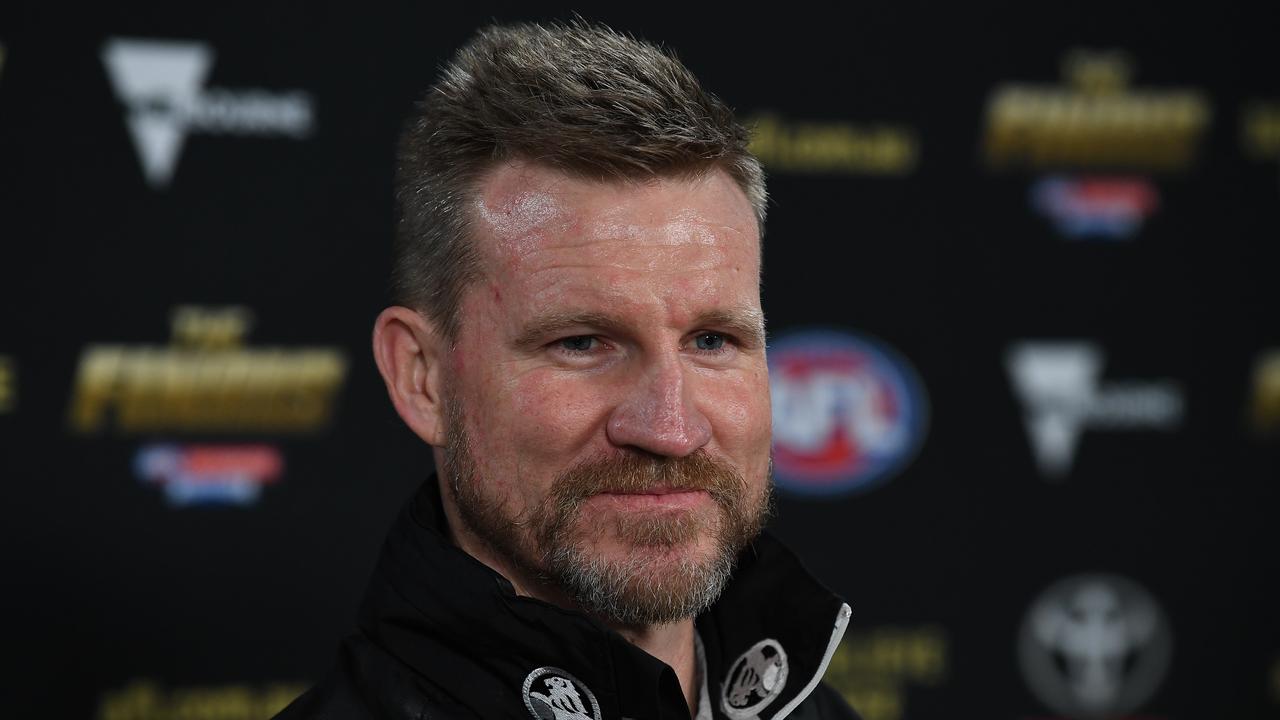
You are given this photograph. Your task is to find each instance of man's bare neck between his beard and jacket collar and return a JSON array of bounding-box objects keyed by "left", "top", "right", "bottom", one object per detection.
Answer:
[{"left": 442, "top": 488, "right": 701, "bottom": 717}]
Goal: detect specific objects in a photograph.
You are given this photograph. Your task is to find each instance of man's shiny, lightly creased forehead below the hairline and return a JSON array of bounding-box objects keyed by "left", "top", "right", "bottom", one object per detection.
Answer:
[{"left": 474, "top": 161, "right": 759, "bottom": 282}]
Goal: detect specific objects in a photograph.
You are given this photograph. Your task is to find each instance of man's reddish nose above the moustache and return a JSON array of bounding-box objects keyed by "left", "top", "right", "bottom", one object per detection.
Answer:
[{"left": 607, "top": 355, "right": 712, "bottom": 457}]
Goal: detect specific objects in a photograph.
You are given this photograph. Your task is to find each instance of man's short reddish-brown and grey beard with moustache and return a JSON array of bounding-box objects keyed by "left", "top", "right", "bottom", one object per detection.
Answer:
[{"left": 440, "top": 398, "right": 772, "bottom": 626}]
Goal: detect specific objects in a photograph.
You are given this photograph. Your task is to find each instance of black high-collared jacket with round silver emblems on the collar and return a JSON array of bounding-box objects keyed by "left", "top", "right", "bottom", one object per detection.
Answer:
[{"left": 278, "top": 478, "right": 858, "bottom": 720}]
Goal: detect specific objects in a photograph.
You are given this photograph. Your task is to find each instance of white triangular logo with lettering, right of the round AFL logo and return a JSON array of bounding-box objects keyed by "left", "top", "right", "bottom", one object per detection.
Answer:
[{"left": 1005, "top": 342, "right": 1184, "bottom": 479}]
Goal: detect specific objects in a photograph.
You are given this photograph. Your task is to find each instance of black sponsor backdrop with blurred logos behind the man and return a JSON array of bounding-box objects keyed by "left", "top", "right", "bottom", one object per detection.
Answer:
[{"left": 0, "top": 4, "right": 1280, "bottom": 720}]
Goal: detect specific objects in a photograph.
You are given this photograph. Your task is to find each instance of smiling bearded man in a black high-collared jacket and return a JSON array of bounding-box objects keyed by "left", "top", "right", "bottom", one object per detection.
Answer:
[{"left": 283, "top": 22, "right": 854, "bottom": 720}]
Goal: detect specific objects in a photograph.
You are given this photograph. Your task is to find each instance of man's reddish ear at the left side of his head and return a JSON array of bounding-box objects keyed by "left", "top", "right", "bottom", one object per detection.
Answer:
[{"left": 374, "top": 306, "right": 445, "bottom": 447}]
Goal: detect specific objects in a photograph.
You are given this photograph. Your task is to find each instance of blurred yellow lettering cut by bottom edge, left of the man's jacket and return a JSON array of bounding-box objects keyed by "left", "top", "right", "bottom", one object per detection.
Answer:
[{"left": 95, "top": 679, "right": 307, "bottom": 720}]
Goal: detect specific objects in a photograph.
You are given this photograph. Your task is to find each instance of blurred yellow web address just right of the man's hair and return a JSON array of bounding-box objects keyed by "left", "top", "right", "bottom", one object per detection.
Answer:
[{"left": 746, "top": 114, "right": 920, "bottom": 176}]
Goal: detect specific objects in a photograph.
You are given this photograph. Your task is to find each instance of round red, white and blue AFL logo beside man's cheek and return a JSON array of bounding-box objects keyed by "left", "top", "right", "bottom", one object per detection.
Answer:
[{"left": 769, "top": 331, "right": 928, "bottom": 495}]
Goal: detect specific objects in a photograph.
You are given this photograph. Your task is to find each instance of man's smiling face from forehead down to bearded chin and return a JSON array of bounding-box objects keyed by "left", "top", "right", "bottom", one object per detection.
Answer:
[{"left": 443, "top": 163, "right": 771, "bottom": 625}]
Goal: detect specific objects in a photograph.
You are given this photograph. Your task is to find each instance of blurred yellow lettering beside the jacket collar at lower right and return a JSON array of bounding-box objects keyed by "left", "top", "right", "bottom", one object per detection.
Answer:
[{"left": 823, "top": 624, "right": 951, "bottom": 720}]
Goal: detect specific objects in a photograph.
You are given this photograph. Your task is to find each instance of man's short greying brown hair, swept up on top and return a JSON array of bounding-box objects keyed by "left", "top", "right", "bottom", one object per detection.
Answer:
[{"left": 392, "top": 19, "right": 767, "bottom": 340}]
